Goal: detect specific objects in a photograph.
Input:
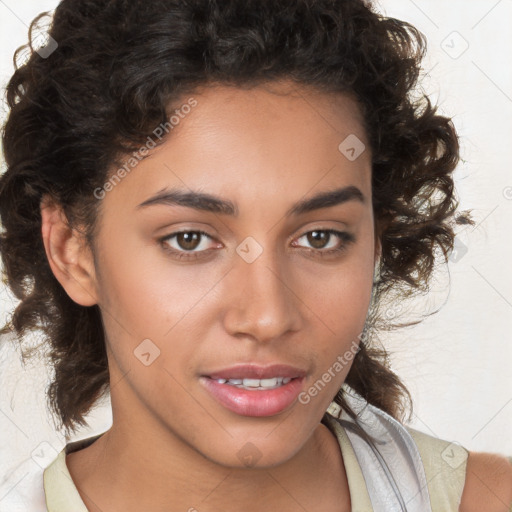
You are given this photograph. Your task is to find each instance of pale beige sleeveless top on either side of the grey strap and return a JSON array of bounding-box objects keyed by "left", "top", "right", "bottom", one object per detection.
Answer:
[{"left": 43, "top": 421, "right": 468, "bottom": 512}]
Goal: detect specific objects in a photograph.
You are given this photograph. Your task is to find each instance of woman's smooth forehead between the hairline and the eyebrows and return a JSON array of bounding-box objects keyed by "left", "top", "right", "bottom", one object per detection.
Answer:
[{"left": 103, "top": 82, "right": 371, "bottom": 214}]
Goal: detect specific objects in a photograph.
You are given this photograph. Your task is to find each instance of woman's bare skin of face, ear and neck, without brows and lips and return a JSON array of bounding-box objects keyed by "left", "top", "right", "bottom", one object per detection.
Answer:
[{"left": 42, "top": 82, "right": 512, "bottom": 512}]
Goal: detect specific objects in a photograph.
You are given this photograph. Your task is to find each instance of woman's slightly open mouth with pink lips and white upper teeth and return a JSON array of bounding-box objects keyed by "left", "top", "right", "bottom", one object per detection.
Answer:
[{"left": 200, "top": 365, "right": 306, "bottom": 417}]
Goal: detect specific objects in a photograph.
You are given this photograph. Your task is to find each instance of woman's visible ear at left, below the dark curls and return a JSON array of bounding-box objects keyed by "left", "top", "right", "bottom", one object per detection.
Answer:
[{"left": 41, "top": 195, "right": 98, "bottom": 306}]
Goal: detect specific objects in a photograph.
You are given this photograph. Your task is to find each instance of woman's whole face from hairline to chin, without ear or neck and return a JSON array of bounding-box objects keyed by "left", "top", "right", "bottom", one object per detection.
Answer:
[{"left": 86, "top": 83, "right": 376, "bottom": 467}]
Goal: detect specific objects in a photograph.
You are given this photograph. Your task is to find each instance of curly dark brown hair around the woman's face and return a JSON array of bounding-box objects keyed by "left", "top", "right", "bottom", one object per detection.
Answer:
[{"left": 0, "top": 0, "right": 472, "bottom": 432}]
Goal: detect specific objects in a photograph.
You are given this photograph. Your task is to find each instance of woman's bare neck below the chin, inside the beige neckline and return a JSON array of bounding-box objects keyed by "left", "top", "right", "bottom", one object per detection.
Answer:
[{"left": 67, "top": 412, "right": 350, "bottom": 512}]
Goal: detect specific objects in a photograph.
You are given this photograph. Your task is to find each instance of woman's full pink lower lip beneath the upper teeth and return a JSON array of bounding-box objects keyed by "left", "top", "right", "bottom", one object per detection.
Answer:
[{"left": 200, "top": 377, "right": 304, "bottom": 416}]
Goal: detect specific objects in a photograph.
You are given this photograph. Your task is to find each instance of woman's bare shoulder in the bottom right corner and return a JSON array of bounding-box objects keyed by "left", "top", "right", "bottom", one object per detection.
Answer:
[{"left": 459, "top": 452, "right": 512, "bottom": 512}]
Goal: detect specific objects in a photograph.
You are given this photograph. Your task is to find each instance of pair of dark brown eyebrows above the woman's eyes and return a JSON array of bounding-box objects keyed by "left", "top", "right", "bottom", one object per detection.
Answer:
[{"left": 137, "top": 185, "right": 366, "bottom": 217}]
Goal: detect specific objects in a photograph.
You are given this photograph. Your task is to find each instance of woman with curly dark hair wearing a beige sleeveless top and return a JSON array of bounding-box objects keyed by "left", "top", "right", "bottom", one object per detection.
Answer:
[{"left": 0, "top": 0, "right": 512, "bottom": 512}]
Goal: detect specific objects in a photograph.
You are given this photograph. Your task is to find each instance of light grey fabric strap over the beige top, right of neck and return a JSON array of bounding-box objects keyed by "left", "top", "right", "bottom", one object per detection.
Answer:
[{"left": 328, "top": 393, "right": 432, "bottom": 512}]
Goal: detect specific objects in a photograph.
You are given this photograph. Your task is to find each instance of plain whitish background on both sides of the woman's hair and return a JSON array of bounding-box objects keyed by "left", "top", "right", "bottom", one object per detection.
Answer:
[{"left": 0, "top": 0, "right": 512, "bottom": 498}]
